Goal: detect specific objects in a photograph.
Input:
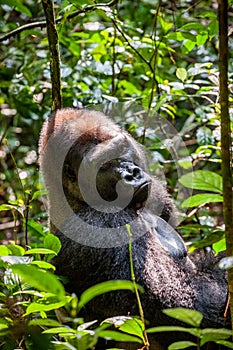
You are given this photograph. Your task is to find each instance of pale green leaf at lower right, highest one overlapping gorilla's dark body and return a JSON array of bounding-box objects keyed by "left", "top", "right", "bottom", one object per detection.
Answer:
[{"left": 163, "top": 308, "right": 203, "bottom": 327}]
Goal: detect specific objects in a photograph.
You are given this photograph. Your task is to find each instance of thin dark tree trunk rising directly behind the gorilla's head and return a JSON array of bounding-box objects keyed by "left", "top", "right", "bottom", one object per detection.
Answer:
[{"left": 42, "top": 0, "right": 62, "bottom": 111}]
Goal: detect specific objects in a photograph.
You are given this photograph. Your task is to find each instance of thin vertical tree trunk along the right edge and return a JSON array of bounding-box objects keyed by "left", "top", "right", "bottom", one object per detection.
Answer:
[{"left": 218, "top": 0, "right": 233, "bottom": 329}]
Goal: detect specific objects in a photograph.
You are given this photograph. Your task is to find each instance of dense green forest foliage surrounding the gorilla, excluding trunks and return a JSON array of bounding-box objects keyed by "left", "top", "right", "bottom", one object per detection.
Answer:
[{"left": 0, "top": 0, "right": 233, "bottom": 349}]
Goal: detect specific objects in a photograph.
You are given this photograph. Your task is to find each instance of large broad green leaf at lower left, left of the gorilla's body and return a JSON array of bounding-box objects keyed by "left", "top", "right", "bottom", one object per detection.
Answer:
[{"left": 11, "top": 264, "right": 65, "bottom": 298}]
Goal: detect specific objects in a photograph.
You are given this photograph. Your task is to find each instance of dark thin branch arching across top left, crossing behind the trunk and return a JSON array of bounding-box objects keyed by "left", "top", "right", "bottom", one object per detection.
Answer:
[{"left": 0, "top": 0, "right": 118, "bottom": 42}]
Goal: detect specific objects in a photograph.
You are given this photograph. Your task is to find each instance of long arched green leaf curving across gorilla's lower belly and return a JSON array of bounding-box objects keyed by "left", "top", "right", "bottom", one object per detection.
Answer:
[{"left": 78, "top": 280, "right": 143, "bottom": 310}]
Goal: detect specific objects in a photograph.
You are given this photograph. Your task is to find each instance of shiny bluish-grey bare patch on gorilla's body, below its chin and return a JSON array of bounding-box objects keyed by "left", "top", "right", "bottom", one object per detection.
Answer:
[{"left": 156, "top": 216, "right": 187, "bottom": 259}]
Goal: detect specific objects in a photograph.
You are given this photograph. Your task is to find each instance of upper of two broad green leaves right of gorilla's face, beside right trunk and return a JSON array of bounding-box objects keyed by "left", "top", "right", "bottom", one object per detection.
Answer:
[{"left": 179, "top": 170, "right": 222, "bottom": 194}]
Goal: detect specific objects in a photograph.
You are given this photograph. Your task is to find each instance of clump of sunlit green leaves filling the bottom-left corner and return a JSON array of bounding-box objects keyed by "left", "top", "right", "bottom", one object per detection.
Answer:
[{"left": 0, "top": 234, "right": 143, "bottom": 350}]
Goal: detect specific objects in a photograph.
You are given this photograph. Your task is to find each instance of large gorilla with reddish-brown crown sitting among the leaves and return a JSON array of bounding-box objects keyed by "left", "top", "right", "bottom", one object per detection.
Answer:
[{"left": 39, "top": 108, "right": 227, "bottom": 349}]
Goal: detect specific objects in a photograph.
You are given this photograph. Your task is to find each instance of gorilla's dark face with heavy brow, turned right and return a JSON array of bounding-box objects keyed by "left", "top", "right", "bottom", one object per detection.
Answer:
[{"left": 63, "top": 133, "right": 152, "bottom": 212}]
